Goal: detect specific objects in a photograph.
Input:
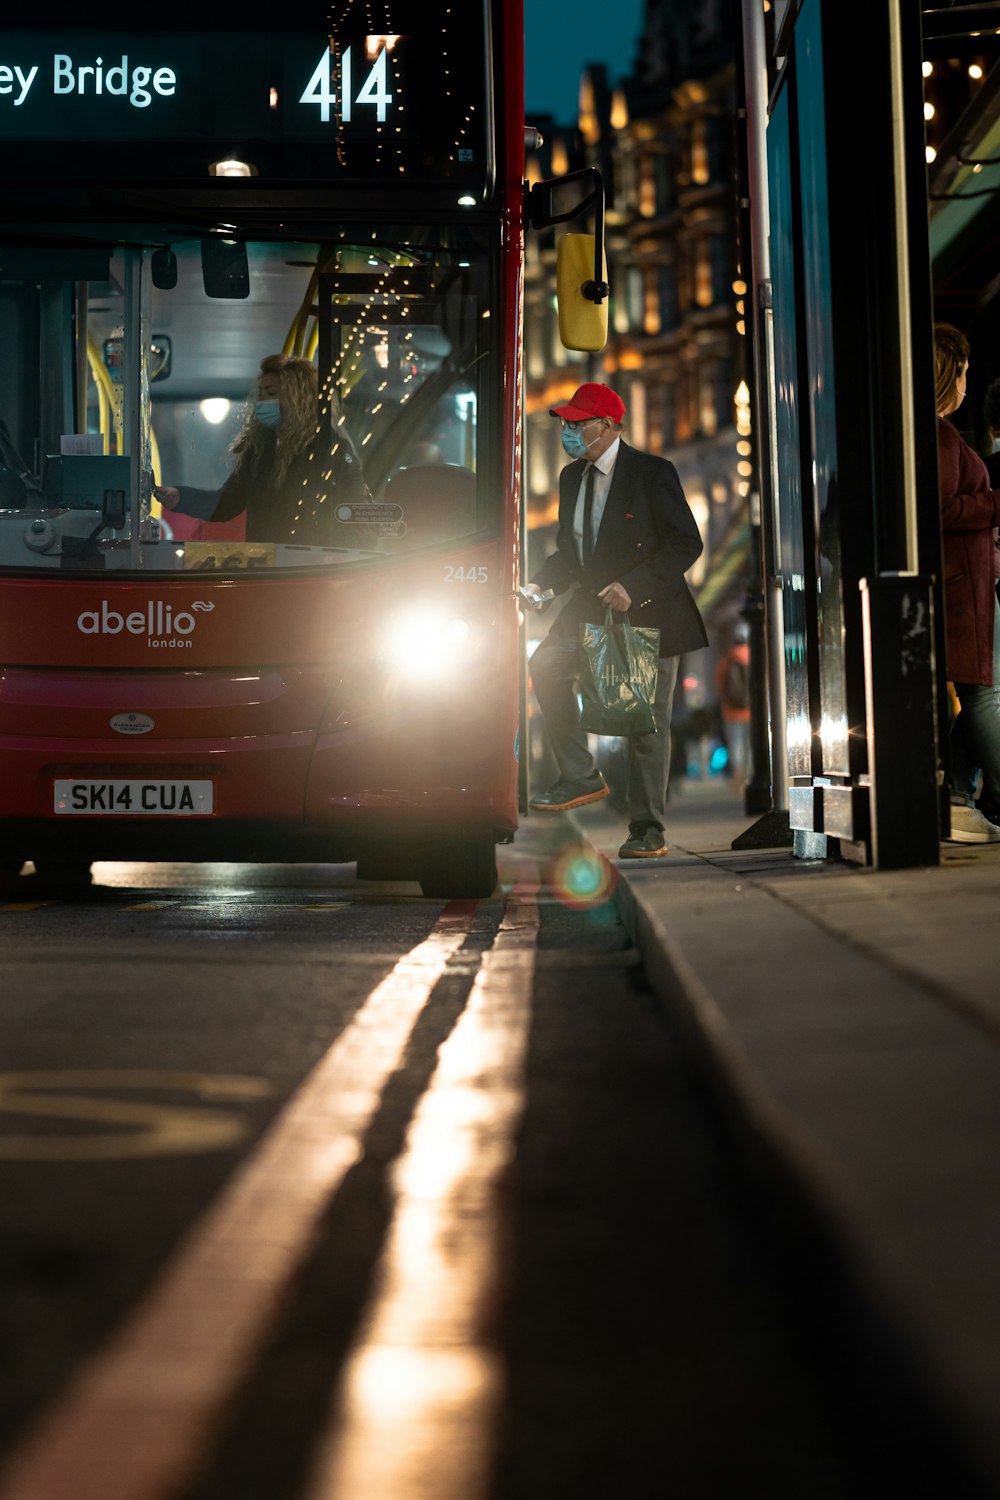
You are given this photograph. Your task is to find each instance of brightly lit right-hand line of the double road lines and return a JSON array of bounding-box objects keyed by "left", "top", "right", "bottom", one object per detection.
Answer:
[{"left": 304, "top": 894, "right": 538, "bottom": 1500}]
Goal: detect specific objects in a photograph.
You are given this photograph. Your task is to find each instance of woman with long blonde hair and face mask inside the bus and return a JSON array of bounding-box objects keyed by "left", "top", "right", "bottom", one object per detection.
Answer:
[{"left": 153, "top": 354, "right": 370, "bottom": 546}]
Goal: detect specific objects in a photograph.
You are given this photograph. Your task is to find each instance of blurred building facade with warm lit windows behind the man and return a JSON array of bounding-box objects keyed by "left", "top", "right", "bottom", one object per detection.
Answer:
[{"left": 525, "top": 0, "right": 754, "bottom": 657}]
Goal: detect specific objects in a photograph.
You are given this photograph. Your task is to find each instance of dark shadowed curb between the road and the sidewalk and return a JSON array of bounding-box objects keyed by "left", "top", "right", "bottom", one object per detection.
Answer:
[{"left": 611, "top": 864, "right": 1000, "bottom": 1500}]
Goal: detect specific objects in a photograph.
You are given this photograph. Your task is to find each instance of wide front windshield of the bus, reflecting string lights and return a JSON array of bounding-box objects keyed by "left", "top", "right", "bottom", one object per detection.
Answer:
[{"left": 0, "top": 224, "right": 501, "bottom": 573}]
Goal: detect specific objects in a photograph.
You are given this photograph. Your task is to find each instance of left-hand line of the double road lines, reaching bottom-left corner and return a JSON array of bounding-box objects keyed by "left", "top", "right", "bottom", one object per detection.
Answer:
[{"left": 0, "top": 902, "right": 477, "bottom": 1500}]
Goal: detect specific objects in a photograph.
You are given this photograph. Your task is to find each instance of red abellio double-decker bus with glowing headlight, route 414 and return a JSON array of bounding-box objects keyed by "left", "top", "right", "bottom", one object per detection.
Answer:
[{"left": 0, "top": 0, "right": 611, "bottom": 896}]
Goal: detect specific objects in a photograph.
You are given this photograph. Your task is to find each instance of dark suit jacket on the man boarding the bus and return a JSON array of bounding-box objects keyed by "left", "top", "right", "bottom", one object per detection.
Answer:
[{"left": 532, "top": 441, "right": 708, "bottom": 656}]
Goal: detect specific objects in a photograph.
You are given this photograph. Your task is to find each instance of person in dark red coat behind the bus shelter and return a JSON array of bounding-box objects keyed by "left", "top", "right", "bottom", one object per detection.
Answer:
[{"left": 934, "top": 323, "right": 1000, "bottom": 843}]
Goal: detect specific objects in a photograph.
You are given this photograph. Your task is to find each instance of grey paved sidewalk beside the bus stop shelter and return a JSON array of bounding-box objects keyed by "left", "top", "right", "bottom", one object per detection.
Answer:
[{"left": 563, "top": 782, "right": 1000, "bottom": 1496}]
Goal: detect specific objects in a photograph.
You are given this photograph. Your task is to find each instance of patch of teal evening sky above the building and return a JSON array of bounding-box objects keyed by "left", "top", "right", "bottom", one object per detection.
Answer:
[{"left": 525, "top": 0, "right": 646, "bottom": 125}]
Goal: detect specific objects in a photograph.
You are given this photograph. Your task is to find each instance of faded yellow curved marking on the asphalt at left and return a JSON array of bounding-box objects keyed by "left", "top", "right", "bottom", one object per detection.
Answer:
[{"left": 0, "top": 1068, "right": 273, "bottom": 1161}]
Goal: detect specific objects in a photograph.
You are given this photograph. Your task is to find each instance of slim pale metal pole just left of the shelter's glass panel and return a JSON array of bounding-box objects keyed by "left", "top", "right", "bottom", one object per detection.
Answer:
[{"left": 742, "top": 0, "right": 789, "bottom": 812}]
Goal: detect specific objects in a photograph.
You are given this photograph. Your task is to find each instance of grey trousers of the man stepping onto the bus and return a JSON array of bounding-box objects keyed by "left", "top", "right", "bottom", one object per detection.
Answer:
[{"left": 531, "top": 629, "right": 681, "bottom": 828}]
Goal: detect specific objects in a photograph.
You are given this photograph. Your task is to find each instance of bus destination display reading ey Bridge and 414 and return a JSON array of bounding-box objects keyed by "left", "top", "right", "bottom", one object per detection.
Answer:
[{"left": 0, "top": 25, "right": 489, "bottom": 183}]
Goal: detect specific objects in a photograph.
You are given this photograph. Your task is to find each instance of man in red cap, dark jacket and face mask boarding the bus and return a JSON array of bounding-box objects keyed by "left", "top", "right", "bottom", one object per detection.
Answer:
[{"left": 531, "top": 383, "right": 708, "bottom": 860}]
